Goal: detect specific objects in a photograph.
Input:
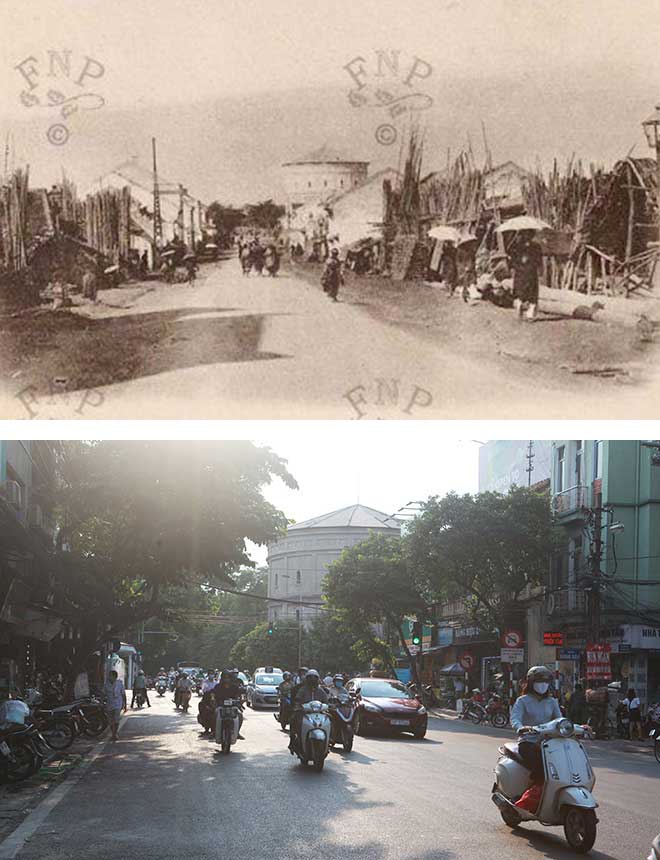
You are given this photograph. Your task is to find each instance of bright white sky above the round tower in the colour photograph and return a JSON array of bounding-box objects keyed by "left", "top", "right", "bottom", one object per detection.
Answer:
[{"left": 245, "top": 434, "right": 479, "bottom": 564}]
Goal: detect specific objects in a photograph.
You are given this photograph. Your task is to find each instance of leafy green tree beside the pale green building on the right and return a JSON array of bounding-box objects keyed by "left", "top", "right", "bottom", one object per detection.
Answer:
[{"left": 405, "top": 487, "right": 557, "bottom": 631}]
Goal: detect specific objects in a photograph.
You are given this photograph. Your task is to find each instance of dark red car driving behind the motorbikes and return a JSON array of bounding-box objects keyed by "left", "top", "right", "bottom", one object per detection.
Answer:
[{"left": 346, "top": 678, "right": 428, "bottom": 740}]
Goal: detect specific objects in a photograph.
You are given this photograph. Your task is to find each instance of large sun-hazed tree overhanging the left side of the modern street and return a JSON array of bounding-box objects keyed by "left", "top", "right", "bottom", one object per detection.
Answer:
[{"left": 58, "top": 442, "right": 297, "bottom": 680}]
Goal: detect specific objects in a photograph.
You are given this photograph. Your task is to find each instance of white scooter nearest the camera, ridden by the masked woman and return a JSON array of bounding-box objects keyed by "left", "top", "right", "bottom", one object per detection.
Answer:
[{"left": 492, "top": 717, "right": 598, "bottom": 853}]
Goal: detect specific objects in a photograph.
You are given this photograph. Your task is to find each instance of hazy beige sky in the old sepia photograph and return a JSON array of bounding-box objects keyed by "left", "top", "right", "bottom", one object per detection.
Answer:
[{"left": 0, "top": 0, "right": 660, "bottom": 203}]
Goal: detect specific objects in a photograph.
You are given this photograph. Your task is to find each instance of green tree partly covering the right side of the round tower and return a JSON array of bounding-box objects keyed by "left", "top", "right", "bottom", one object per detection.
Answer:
[{"left": 325, "top": 534, "right": 426, "bottom": 674}]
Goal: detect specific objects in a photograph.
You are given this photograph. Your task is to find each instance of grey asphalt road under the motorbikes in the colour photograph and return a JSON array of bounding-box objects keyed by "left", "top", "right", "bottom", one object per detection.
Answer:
[{"left": 6, "top": 700, "right": 660, "bottom": 860}]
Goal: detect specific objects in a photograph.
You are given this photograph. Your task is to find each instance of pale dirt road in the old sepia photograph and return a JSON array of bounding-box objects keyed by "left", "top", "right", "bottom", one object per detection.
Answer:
[{"left": 2, "top": 254, "right": 657, "bottom": 419}]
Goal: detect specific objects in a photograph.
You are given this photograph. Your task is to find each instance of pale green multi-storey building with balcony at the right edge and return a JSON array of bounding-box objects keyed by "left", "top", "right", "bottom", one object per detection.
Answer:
[{"left": 545, "top": 440, "right": 660, "bottom": 705}]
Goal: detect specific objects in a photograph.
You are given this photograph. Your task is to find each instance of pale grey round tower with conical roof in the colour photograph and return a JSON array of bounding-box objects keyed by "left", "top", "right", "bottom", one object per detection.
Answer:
[{"left": 268, "top": 505, "right": 401, "bottom": 624}]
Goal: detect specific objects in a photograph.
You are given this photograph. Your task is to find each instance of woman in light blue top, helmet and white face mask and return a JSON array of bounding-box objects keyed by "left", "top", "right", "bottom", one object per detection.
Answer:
[{"left": 511, "top": 666, "right": 561, "bottom": 812}]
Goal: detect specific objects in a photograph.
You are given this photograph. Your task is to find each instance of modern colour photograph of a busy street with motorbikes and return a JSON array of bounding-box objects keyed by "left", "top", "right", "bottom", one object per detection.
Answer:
[{"left": 0, "top": 436, "right": 660, "bottom": 860}]
